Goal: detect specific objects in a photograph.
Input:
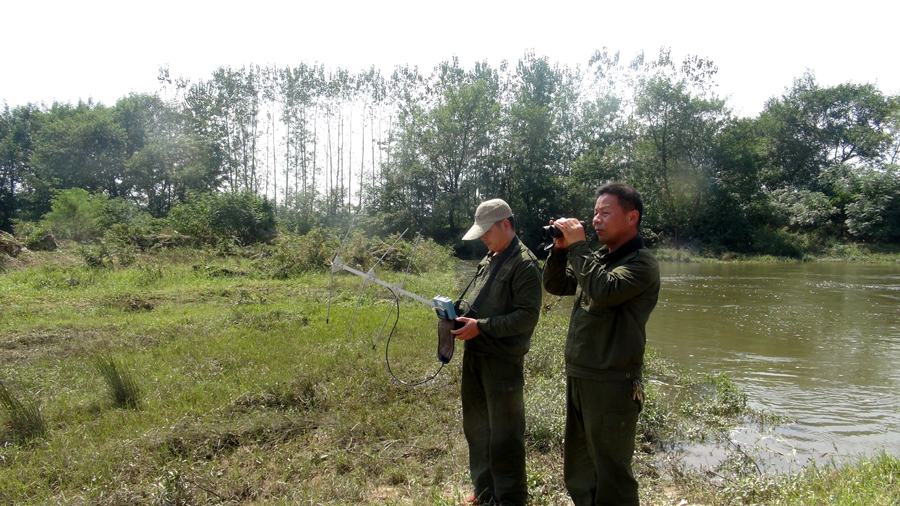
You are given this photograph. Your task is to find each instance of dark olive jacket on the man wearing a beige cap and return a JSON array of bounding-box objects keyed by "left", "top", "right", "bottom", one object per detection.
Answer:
[{"left": 466, "top": 237, "right": 543, "bottom": 356}]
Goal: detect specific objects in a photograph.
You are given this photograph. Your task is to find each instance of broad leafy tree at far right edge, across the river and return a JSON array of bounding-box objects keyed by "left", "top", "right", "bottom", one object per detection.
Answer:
[{"left": 759, "top": 72, "right": 900, "bottom": 241}]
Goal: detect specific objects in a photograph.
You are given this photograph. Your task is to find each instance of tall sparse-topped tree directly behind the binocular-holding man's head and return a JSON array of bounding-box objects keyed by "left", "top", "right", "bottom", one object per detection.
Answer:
[{"left": 573, "top": 48, "right": 736, "bottom": 244}]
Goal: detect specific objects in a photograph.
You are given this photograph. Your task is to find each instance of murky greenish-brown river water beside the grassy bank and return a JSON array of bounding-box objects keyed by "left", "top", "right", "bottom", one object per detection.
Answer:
[{"left": 648, "top": 263, "right": 900, "bottom": 464}]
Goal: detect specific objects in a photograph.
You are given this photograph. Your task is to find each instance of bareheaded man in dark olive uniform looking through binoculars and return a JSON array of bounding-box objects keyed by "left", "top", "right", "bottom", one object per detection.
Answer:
[{"left": 543, "top": 183, "right": 660, "bottom": 506}]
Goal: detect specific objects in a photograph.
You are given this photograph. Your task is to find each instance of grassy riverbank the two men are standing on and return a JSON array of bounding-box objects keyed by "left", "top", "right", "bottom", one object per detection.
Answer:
[{"left": 0, "top": 240, "right": 900, "bottom": 505}]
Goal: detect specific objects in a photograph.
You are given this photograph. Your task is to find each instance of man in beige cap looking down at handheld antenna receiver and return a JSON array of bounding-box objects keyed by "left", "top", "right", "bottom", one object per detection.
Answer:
[{"left": 453, "top": 199, "right": 542, "bottom": 506}]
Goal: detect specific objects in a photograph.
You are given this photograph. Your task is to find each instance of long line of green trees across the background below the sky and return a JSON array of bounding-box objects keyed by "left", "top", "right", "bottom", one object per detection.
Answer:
[{"left": 0, "top": 49, "right": 900, "bottom": 256}]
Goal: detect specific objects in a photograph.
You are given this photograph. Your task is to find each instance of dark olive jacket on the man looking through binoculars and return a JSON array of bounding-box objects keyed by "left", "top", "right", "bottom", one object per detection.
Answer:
[{"left": 543, "top": 236, "right": 659, "bottom": 381}]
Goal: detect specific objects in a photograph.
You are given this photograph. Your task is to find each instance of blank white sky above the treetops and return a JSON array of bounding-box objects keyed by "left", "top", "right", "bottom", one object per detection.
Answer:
[{"left": 7, "top": 0, "right": 900, "bottom": 116}]
